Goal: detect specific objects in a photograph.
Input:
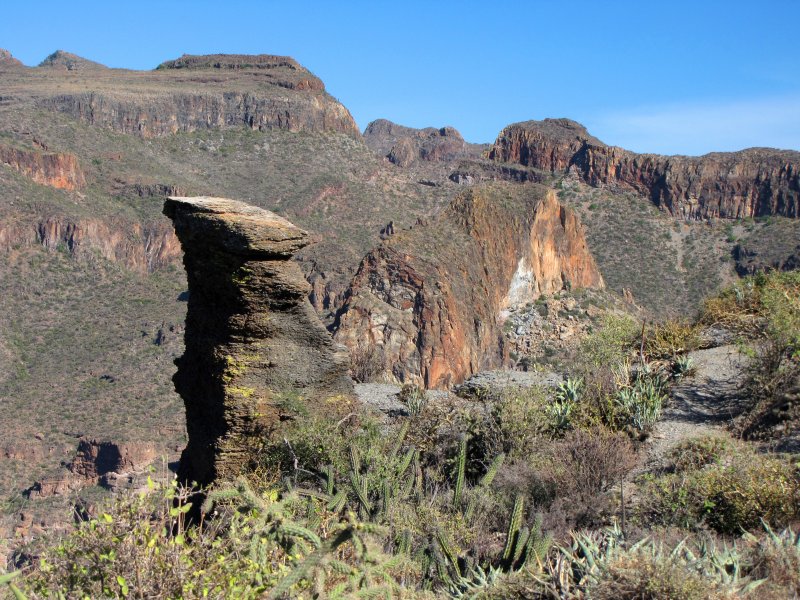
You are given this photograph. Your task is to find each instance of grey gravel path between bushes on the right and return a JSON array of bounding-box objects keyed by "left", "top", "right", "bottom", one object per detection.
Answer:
[{"left": 637, "top": 345, "right": 749, "bottom": 473}]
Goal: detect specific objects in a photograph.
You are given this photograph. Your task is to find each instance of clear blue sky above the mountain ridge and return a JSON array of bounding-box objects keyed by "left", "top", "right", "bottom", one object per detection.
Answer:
[{"left": 0, "top": 0, "right": 800, "bottom": 154}]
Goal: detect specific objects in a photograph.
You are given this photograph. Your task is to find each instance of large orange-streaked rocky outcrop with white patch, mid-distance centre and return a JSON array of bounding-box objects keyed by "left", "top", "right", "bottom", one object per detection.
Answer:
[{"left": 335, "top": 185, "right": 603, "bottom": 388}]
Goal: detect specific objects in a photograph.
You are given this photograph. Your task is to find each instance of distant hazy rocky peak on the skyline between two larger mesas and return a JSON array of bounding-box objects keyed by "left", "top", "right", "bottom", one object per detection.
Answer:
[{"left": 364, "top": 119, "right": 482, "bottom": 167}]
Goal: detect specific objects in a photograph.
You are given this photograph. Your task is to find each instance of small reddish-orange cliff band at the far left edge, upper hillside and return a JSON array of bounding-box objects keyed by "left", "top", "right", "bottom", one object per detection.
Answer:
[{"left": 0, "top": 145, "right": 86, "bottom": 190}]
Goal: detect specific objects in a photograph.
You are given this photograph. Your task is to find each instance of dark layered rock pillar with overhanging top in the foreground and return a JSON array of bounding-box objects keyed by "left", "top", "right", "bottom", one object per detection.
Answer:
[{"left": 164, "top": 197, "right": 353, "bottom": 485}]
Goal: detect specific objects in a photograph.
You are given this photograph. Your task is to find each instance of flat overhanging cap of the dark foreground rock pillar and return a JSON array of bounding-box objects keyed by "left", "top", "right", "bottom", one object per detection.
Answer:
[{"left": 164, "top": 196, "right": 309, "bottom": 258}]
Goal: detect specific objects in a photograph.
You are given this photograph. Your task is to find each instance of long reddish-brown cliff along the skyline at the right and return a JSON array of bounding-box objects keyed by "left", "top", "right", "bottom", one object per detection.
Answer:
[{"left": 489, "top": 119, "right": 800, "bottom": 219}]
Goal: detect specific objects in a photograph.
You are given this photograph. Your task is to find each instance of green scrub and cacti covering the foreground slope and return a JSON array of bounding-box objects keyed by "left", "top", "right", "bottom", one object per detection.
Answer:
[{"left": 12, "top": 274, "right": 800, "bottom": 599}]
